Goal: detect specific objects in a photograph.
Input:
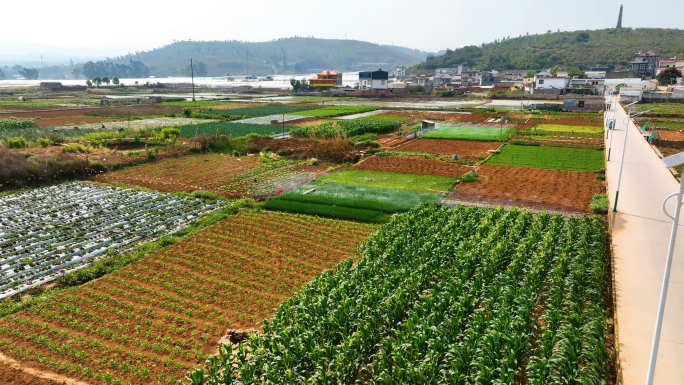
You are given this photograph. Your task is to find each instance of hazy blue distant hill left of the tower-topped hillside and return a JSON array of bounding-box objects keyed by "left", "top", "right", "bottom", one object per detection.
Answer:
[{"left": 116, "top": 37, "right": 427, "bottom": 76}]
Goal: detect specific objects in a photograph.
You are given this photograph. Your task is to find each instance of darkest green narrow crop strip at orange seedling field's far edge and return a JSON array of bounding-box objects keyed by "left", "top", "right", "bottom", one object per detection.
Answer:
[{"left": 263, "top": 198, "right": 390, "bottom": 223}]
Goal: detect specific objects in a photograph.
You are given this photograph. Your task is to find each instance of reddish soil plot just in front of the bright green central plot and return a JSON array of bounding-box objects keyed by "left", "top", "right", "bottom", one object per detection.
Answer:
[{"left": 391, "top": 139, "right": 501, "bottom": 159}]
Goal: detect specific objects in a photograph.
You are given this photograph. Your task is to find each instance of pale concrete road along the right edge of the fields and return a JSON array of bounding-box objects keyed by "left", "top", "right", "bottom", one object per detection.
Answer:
[{"left": 606, "top": 100, "right": 684, "bottom": 385}]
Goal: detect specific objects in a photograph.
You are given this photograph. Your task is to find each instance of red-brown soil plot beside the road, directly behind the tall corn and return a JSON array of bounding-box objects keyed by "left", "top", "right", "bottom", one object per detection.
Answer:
[{"left": 449, "top": 165, "right": 603, "bottom": 212}]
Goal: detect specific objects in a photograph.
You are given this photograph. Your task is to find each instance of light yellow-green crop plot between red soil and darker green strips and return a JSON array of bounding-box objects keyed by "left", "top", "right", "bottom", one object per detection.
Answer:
[{"left": 316, "top": 169, "right": 456, "bottom": 193}]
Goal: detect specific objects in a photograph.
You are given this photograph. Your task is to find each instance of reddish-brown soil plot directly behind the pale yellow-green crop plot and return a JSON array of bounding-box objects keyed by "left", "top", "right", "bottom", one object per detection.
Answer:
[{"left": 352, "top": 156, "right": 472, "bottom": 178}]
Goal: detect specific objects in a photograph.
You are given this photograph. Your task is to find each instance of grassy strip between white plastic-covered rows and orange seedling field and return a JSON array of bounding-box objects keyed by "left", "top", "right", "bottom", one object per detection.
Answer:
[{"left": 0, "top": 193, "right": 259, "bottom": 317}]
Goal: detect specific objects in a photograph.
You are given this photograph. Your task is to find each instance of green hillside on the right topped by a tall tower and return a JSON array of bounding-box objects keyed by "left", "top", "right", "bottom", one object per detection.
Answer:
[{"left": 414, "top": 28, "right": 684, "bottom": 70}]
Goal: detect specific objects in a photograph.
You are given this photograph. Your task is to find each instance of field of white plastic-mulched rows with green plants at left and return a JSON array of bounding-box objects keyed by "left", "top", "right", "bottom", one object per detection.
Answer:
[{"left": 0, "top": 183, "right": 219, "bottom": 298}]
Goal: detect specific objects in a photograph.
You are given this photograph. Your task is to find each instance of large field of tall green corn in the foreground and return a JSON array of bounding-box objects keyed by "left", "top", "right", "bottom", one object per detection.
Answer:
[{"left": 190, "top": 205, "right": 613, "bottom": 384}]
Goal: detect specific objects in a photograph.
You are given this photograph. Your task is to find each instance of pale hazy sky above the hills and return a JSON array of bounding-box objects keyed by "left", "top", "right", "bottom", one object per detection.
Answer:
[{"left": 0, "top": 0, "right": 684, "bottom": 59}]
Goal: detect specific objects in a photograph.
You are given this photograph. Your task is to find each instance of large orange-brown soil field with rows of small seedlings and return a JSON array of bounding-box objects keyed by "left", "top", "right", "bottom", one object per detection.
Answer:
[{"left": 0, "top": 212, "right": 375, "bottom": 384}]
